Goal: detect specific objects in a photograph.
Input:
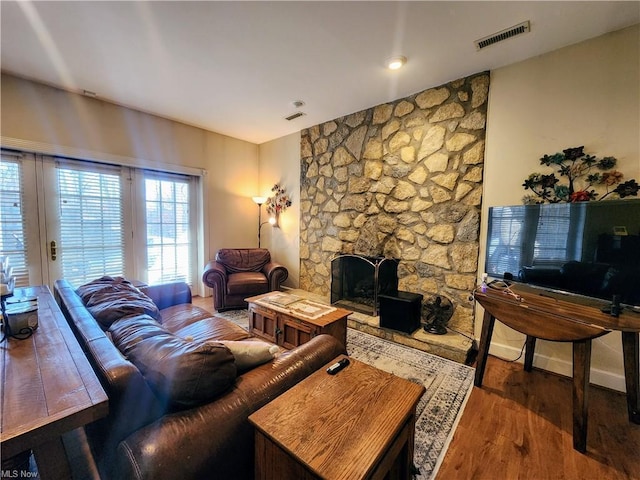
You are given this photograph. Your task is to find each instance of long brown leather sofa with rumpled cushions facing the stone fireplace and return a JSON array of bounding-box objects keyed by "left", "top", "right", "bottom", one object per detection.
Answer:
[{"left": 54, "top": 280, "right": 345, "bottom": 480}]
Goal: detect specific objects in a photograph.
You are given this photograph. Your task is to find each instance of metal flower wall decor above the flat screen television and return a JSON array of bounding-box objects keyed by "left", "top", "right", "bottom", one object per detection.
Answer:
[{"left": 522, "top": 146, "right": 640, "bottom": 204}]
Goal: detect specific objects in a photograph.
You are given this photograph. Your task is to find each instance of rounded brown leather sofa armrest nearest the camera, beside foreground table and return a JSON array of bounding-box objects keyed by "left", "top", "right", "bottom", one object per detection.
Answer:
[{"left": 114, "top": 335, "right": 345, "bottom": 480}]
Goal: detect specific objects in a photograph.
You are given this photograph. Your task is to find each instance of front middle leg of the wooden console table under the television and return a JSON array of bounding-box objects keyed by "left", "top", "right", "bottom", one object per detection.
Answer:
[{"left": 573, "top": 339, "right": 591, "bottom": 453}]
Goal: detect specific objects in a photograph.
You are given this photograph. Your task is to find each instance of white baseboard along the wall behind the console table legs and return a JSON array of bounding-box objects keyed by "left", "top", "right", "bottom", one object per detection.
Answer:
[{"left": 489, "top": 343, "right": 627, "bottom": 392}]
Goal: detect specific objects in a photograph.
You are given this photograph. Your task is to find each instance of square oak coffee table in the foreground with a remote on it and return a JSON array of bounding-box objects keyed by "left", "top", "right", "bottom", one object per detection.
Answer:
[{"left": 249, "top": 356, "right": 425, "bottom": 480}]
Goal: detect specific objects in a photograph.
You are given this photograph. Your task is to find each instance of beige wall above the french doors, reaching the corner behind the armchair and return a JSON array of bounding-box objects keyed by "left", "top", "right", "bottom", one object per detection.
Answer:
[{"left": 0, "top": 74, "right": 258, "bottom": 294}]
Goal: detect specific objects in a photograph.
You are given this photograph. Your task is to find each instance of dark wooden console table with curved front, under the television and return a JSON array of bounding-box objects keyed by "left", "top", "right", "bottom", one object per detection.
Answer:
[{"left": 474, "top": 284, "right": 640, "bottom": 453}]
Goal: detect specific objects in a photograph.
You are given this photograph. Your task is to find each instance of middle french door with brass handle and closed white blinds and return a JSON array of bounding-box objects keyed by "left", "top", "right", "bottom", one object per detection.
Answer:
[{"left": 42, "top": 157, "right": 135, "bottom": 286}]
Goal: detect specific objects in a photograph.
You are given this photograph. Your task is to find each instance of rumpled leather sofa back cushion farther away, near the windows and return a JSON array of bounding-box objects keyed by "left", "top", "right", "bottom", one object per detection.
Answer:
[{"left": 76, "top": 276, "right": 161, "bottom": 330}]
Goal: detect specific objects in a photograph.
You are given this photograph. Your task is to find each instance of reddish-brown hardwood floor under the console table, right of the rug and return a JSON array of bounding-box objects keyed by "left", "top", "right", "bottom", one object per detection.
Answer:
[{"left": 436, "top": 357, "right": 640, "bottom": 480}]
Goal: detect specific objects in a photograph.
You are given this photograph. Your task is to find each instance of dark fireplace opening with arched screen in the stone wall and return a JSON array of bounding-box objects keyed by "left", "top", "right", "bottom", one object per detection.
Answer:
[{"left": 331, "top": 254, "right": 399, "bottom": 317}]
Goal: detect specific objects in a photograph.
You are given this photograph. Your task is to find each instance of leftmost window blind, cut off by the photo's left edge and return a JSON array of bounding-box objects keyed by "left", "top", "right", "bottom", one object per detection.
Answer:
[{"left": 0, "top": 151, "right": 29, "bottom": 287}]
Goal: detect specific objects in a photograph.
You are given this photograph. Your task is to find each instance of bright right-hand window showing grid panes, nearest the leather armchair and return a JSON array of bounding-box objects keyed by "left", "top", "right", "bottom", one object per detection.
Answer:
[{"left": 144, "top": 172, "right": 194, "bottom": 284}]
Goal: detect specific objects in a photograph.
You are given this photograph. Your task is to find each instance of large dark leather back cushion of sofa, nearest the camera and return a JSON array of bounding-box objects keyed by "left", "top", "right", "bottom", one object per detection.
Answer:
[{"left": 109, "top": 315, "right": 237, "bottom": 409}]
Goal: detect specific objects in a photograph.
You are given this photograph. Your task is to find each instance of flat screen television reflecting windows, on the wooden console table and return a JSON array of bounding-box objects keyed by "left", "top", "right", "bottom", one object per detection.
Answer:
[{"left": 485, "top": 199, "right": 640, "bottom": 307}]
